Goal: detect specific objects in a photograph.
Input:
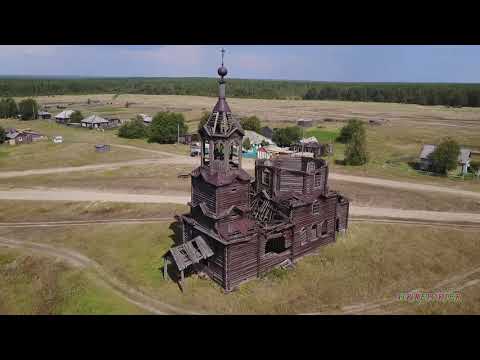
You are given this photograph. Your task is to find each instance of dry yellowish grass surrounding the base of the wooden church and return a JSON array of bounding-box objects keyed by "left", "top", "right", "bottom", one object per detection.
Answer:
[{"left": 0, "top": 218, "right": 480, "bottom": 314}]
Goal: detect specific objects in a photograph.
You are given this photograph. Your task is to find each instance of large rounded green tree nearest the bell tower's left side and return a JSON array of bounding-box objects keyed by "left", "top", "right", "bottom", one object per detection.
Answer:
[{"left": 148, "top": 111, "right": 188, "bottom": 144}]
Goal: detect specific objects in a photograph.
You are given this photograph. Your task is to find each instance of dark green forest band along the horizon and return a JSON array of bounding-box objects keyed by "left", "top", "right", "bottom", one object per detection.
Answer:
[{"left": 0, "top": 77, "right": 480, "bottom": 107}]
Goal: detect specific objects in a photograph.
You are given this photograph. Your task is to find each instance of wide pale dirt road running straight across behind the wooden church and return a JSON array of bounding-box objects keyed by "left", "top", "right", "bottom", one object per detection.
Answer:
[{"left": 0, "top": 189, "right": 480, "bottom": 224}]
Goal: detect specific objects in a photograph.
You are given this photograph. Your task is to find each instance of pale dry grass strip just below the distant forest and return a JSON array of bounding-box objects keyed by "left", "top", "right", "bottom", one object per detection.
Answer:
[{"left": 20, "top": 94, "right": 480, "bottom": 125}]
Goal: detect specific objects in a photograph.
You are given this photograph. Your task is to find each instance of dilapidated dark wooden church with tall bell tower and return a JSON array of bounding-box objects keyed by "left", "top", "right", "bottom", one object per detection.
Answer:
[{"left": 165, "top": 60, "right": 349, "bottom": 291}]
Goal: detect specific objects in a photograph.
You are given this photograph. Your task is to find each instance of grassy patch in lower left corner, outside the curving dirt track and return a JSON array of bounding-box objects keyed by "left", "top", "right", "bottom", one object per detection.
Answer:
[{"left": 0, "top": 248, "right": 145, "bottom": 315}]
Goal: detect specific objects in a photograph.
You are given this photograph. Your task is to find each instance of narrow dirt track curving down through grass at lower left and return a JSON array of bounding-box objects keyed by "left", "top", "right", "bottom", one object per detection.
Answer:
[{"left": 0, "top": 237, "right": 199, "bottom": 315}]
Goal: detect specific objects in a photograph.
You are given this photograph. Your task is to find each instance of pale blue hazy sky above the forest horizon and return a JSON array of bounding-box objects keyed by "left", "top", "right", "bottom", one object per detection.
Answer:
[{"left": 0, "top": 45, "right": 480, "bottom": 83}]
